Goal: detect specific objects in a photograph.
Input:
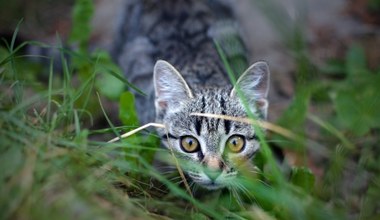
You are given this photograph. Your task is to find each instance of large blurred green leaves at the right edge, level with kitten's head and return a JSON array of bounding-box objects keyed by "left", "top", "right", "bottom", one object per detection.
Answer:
[{"left": 334, "top": 46, "right": 380, "bottom": 136}]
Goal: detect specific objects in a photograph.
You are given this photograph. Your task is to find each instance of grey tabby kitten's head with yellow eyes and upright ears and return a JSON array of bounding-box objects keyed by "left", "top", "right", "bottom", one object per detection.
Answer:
[{"left": 154, "top": 60, "right": 269, "bottom": 189}]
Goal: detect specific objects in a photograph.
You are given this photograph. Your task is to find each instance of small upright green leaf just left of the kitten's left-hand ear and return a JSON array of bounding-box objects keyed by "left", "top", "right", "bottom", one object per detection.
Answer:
[{"left": 119, "top": 91, "right": 139, "bottom": 126}]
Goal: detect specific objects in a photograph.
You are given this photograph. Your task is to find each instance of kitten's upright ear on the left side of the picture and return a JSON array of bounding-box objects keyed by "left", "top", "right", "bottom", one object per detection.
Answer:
[{"left": 153, "top": 60, "right": 193, "bottom": 112}]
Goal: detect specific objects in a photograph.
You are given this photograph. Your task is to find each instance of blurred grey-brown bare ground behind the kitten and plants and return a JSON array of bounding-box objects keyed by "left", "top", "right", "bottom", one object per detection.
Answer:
[{"left": 0, "top": 0, "right": 380, "bottom": 121}]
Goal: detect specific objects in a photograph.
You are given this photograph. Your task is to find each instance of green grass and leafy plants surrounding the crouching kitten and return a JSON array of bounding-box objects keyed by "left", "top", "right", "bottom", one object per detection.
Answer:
[{"left": 0, "top": 0, "right": 380, "bottom": 219}]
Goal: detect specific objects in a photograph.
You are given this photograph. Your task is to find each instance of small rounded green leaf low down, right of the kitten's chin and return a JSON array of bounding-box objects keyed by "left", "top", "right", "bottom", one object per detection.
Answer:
[{"left": 290, "top": 167, "right": 315, "bottom": 192}]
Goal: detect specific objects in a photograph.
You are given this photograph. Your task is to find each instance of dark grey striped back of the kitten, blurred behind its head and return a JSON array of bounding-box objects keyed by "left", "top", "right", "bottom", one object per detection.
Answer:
[{"left": 113, "top": 0, "right": 246, "bottom": 122}]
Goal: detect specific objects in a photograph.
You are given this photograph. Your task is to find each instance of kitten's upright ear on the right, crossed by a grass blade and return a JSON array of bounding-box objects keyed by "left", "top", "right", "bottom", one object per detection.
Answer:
[{"left": 231, "top": 61, "right": 270, "bottom": 118}]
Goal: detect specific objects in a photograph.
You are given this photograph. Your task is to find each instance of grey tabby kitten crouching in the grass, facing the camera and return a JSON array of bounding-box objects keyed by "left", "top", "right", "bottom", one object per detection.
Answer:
[{"left": 113, "top": 0, "right": 269, "bottom": 190}]
